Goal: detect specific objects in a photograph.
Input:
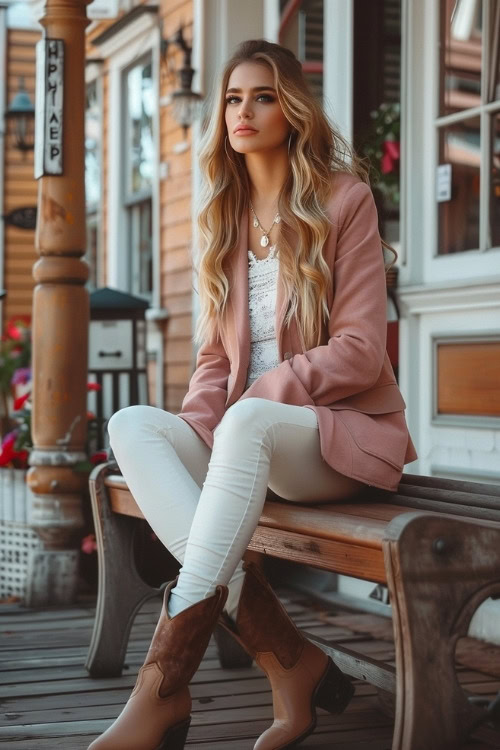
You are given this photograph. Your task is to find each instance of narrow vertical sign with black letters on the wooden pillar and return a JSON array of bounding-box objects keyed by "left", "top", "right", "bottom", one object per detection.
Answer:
[{"left": 35, "top": 39, "right": 64, "bottom": 179}]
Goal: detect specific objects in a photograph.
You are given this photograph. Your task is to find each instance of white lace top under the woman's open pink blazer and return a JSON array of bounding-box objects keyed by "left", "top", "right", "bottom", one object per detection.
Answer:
[{"left": 245, "top": 245, "right": 279, "bottom": 389}]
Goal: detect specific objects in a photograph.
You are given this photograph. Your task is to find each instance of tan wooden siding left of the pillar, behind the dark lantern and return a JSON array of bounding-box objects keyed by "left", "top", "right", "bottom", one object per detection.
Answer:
[{"left": 3, "top": 30, "right": 40, "bottom": 321}]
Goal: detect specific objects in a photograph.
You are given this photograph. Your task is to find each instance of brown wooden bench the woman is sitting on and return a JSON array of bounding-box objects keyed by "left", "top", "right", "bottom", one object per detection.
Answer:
[{"left": 86, "top": 464, "right": 500, "bottom": 750}]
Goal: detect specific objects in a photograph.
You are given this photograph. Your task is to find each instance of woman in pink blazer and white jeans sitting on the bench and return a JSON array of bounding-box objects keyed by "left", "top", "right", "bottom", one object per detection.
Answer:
[{"left": 91, "top": 40, "right": 416, "bottom": 750}]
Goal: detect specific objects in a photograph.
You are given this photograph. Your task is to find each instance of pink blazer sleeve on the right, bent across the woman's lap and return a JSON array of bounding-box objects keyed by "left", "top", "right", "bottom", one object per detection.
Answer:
[{"left": 243, "top": 182, "right": 387, "bottom": 406}]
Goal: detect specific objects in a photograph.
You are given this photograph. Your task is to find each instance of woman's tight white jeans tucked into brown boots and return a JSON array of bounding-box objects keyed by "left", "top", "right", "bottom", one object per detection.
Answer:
[{"left": 108, "top": 398, "right": 362, "bottom": 617}]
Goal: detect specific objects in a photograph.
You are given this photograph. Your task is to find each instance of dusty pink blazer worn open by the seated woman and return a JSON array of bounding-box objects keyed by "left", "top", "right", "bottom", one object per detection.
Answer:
[{"left": 179, "top": 172, "right": 417, "bottom": 491}]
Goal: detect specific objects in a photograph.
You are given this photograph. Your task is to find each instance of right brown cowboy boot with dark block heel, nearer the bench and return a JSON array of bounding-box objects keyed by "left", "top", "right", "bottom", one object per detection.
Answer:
[{"left": 220, "top": 563, "right": 354, "bottom": 750}]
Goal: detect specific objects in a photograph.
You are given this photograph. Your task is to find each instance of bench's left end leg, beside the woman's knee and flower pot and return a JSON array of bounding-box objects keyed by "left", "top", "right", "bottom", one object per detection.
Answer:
[{"left": 85, "top": 465, "right": 161, "bottom": 677}]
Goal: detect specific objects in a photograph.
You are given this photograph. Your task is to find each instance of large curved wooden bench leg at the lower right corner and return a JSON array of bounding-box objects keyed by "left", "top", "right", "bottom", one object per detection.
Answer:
[{"left": 384, "top": 513, "right": 500, "bottom": 750}]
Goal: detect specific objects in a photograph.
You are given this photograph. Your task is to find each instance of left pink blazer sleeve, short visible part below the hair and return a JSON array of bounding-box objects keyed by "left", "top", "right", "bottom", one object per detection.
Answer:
[{"left": 178, "top": 339, "right": 230, "bottom": 448}]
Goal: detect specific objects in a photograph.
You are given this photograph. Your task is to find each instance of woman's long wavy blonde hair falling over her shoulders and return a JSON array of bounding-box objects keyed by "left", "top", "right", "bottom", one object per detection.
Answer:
[{"left": 195, "top": 39, "right": 396, "bottom": 349}]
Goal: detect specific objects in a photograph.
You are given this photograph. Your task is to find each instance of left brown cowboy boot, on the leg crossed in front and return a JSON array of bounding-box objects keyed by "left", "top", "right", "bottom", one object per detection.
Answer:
[{"left": 89, "top": 580, "right": 227, "bottom": 750}]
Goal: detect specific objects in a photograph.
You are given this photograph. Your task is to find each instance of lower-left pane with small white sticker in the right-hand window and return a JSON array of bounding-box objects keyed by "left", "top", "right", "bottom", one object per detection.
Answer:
[{"left": 438, "top": 117, "right": 480, "bottom": 255}]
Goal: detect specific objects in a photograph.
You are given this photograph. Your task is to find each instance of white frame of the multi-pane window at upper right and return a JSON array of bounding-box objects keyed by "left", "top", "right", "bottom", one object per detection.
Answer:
[{"left": 400, "top": 0, "right": 500, "bottom": 285}]
